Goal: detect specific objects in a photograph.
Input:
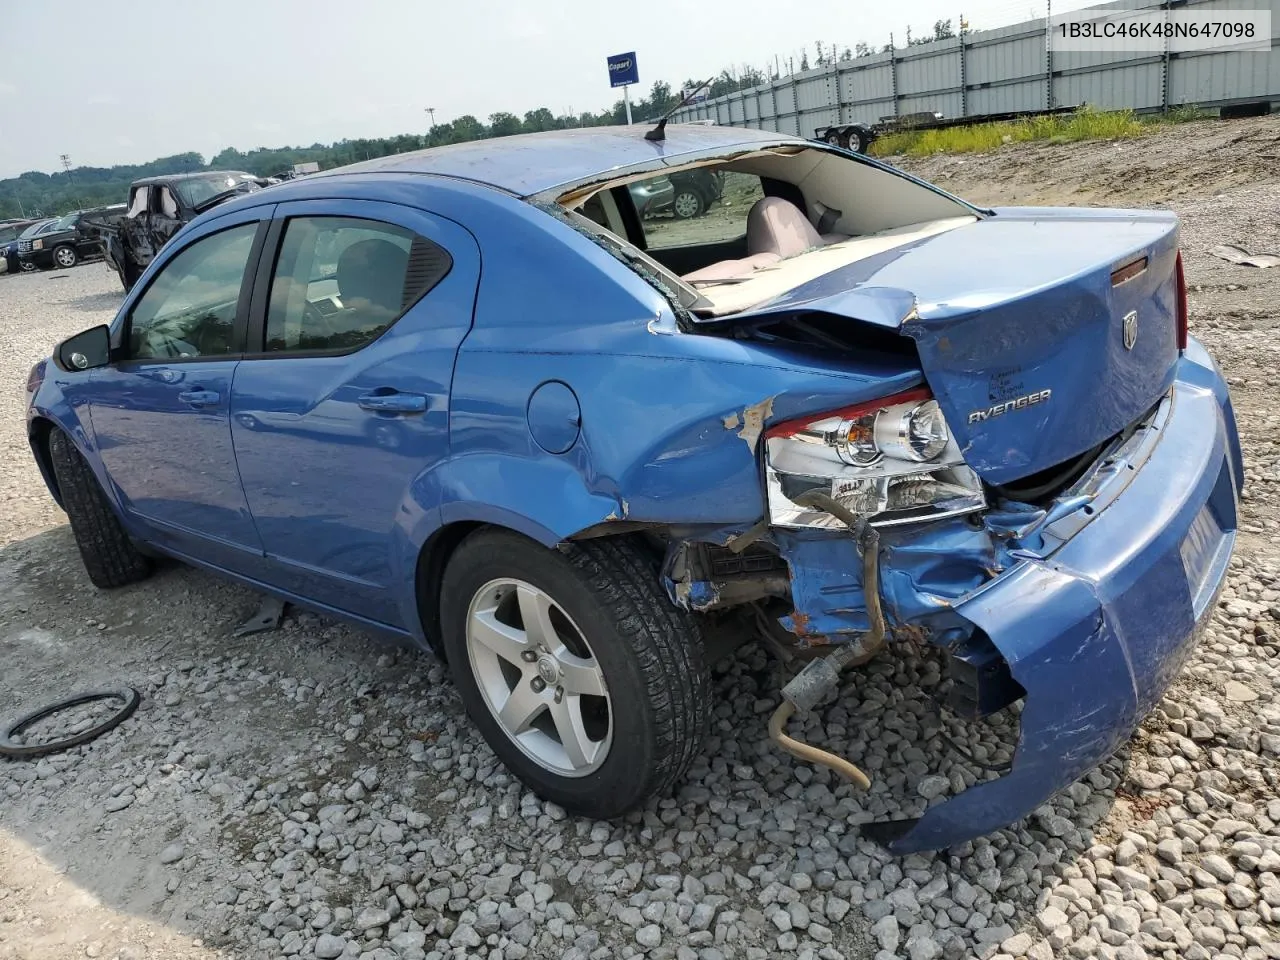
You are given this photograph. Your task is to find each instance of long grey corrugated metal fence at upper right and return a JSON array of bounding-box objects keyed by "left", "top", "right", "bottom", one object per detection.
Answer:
[{"left": 673, "top": 0, "right": 1280, "bottom": 137}]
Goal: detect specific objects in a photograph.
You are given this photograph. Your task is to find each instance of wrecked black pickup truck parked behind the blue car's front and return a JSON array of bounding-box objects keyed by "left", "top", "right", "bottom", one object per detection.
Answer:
[{"left": 104, "top": 170, "right": 269, "bottom": 291}]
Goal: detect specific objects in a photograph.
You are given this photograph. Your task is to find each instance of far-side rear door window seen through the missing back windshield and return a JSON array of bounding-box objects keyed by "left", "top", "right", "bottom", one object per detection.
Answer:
[{"left": 630, "top": 169, "right": 764, "bottom": 250}]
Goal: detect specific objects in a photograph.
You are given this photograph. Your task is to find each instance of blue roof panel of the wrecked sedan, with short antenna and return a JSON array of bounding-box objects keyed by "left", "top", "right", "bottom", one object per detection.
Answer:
[{"left": 307, "top": 124, "right": 808, "bottom": 197}]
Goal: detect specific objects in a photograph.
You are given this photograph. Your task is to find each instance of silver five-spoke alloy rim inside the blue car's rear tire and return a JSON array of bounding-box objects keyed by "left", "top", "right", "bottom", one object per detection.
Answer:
[{"left": 466, "top": 579, "right": 613, "bottom": 777}]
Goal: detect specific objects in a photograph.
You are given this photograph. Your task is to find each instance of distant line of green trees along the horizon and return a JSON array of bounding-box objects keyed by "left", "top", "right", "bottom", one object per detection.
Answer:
[{"left": 0, "top": 20, "right": 968, "bottom": 220}]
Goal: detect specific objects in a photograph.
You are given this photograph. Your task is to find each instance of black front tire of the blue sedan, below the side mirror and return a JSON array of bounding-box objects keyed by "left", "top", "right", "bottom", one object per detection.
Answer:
[{"left": 49, "top": 430, "right": 151, "bottom": 589}]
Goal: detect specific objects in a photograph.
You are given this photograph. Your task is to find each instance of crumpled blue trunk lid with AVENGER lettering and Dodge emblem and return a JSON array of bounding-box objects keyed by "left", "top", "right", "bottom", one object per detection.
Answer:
[{"left": 711, "top": 209, "right": 1178, "bottom": 484}]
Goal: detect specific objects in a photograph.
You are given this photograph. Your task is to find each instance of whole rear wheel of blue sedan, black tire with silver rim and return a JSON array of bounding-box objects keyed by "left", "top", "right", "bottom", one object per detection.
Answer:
[{"left": 440, "top": 530, "right": 710, "bottom": 819}]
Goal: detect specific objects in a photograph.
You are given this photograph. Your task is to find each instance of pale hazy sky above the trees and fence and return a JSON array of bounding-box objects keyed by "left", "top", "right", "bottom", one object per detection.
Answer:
[{"left": 0, "top": 0, "right": 1085, "bottom": 178}]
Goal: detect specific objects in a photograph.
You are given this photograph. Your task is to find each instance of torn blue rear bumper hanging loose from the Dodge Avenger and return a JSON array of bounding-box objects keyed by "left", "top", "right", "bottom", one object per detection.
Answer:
[{"left": 863, "top": 343, "right": 1243, "bottom": 854}]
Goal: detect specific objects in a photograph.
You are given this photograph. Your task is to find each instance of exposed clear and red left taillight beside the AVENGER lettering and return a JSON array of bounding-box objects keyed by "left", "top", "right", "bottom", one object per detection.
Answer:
[{"left": 764, "top": 389, "right": 987, "bottom": 527}]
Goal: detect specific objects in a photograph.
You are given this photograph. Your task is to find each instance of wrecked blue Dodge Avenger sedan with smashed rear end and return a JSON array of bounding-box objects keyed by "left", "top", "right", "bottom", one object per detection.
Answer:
[{"left": 27, "top": 125, "right": 1243, "bottom": 852}]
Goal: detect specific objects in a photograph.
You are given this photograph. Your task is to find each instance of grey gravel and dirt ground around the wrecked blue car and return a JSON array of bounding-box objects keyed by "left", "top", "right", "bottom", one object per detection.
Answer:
[{"left": 0, "top": 120, "right": 1280, "bottom": 960}]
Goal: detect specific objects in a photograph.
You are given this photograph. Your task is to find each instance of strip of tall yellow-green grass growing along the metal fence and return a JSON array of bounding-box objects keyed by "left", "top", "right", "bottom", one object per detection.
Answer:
[{"left": 869, "top": 108, "right": 1162, "bottom": 156}]
